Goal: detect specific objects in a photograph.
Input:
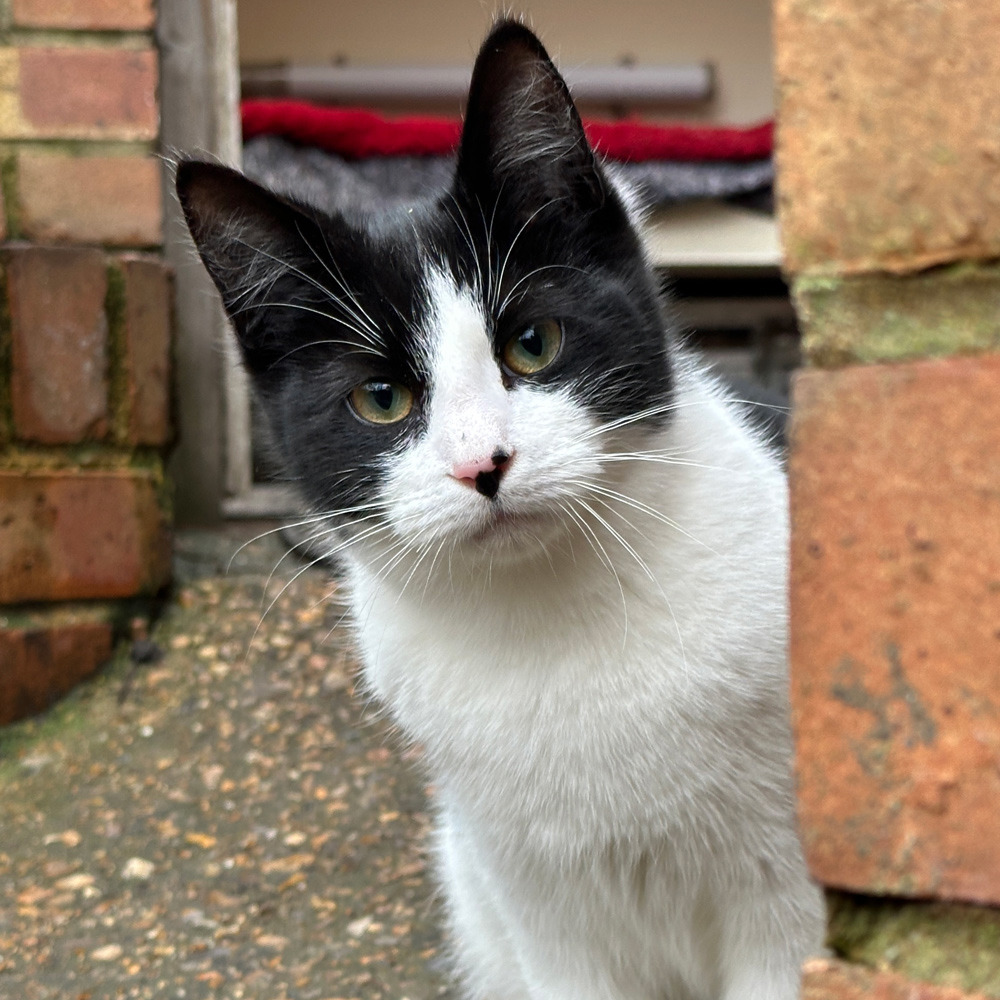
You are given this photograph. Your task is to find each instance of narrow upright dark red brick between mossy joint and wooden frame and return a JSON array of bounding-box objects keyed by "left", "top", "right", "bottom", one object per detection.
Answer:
[{"left": 121, "top": 257, "right": 172, "bottom": 445}]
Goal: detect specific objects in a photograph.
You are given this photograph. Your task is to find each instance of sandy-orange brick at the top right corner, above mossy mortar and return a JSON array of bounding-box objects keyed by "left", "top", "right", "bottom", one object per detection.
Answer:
[{"left": 774, "top": 0, "right": 1000, "bottom": 273}]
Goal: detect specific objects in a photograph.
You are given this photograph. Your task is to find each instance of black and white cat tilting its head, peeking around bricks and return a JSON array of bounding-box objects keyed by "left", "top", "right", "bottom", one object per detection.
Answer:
[{"left": 177, "top": 20, "right": 824, "bottom": 1000}]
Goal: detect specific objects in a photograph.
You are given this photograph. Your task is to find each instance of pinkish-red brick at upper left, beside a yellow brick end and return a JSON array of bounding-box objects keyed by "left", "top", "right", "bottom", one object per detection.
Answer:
[{"left": 19, "top": 47, "right": 159, "bottom": 139}]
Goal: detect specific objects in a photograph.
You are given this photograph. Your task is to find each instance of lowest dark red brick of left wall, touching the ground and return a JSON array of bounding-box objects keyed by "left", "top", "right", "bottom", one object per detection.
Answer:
[{"left": 0, "top": 620, "right": 112, "bottom": 726}]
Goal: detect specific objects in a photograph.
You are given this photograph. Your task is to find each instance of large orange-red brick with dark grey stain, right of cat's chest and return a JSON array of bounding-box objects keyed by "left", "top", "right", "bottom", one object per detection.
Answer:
[{"left": 790, "top": 355, "right": 1000, "bottom": 903}]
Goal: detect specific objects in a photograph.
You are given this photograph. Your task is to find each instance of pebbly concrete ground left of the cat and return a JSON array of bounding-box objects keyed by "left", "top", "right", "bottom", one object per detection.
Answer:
[{"left": 0, "top": 528, "right": 451, "bottom": 1000}]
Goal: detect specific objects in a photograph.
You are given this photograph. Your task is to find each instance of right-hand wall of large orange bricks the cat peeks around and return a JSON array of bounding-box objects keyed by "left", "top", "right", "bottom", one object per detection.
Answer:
[{"left": 775, "top": 0, "right": 1000, "bottom": 1000}]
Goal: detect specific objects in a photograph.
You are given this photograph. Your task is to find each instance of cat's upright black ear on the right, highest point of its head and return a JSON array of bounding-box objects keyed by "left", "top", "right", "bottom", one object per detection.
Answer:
[{"left": 457, "top": 21, "right": 607, "bottom": 209}]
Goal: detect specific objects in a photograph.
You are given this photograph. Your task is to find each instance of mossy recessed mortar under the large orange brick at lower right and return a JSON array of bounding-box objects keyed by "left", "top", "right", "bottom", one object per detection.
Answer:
[{"left": 827, "top": 892, "right": 1000, "bottom": 998}]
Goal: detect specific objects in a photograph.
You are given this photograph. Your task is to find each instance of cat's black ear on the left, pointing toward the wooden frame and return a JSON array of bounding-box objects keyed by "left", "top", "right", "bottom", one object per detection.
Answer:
[{"left": 176, "top": 160, "right": 325, "bottom": 374}]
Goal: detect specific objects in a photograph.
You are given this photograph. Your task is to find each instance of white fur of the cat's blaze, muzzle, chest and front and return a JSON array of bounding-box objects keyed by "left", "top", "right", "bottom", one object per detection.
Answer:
[{"left": 340, "top": 268, "right": 823, "bottom": 1000}]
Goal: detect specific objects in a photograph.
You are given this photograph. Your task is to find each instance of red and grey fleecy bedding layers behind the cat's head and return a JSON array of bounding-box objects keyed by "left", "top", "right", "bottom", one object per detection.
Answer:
[{"left": 242, "top": 100, "right": 774, "bottom": 217}]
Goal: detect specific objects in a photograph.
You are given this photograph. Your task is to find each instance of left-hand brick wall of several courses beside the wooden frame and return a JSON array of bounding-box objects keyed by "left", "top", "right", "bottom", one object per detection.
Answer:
[{"left": 0, "top": 0, "right": 172, "bottom": 724}]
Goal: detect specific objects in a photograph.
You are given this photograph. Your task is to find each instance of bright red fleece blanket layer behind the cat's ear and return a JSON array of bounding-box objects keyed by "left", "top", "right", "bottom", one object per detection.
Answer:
[{"left": 242, "top": 100, "right": 774, "bottom": 162}]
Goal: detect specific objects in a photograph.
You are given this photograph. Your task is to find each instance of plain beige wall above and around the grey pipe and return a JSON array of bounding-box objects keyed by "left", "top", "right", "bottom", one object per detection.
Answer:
[{"left": 238, "top": 0, "right": 773, "bottom": 123}]
